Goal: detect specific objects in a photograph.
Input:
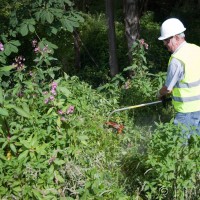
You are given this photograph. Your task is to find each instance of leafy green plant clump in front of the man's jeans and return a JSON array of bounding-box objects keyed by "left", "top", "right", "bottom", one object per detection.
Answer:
[{"left": 143, "top": 121, "right": 200, "bottom": 199}]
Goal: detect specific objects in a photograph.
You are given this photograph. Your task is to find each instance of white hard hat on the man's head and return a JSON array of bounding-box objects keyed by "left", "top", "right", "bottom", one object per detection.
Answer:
[{"left": 158, "top": 18, "right": 186, "bottom": 40}]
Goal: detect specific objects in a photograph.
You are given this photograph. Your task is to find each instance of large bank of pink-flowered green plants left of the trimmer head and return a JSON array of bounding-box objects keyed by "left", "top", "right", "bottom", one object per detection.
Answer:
[{"left": 0, "top": 40, "right": 130, "bottom": 199}]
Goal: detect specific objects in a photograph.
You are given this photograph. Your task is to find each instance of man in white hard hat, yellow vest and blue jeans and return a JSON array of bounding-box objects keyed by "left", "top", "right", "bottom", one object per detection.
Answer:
[{"left": 158, "top": 18, "right": 200, "bottom": 134}]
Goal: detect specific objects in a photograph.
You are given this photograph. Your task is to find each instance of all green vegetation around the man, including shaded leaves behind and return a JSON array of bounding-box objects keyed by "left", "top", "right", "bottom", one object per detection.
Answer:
[{"left": 0, "top": 0, "right": 200, "bottom": 200}]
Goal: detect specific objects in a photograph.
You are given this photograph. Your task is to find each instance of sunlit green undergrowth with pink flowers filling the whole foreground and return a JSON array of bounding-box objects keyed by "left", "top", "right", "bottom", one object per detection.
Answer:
[{"left": 0, "top": 27, "right": 200, "bottom": 200}]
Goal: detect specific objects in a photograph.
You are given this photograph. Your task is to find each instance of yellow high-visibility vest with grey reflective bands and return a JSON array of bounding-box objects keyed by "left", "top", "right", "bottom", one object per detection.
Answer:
[{"left": 169, "top": 43, "right": 200, "bottom": 113}]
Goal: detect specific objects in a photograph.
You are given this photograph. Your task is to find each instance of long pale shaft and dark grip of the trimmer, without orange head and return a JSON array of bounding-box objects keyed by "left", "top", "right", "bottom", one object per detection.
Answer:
[{"left": 108, "top": 98, "right": 172, "bottom": 121}]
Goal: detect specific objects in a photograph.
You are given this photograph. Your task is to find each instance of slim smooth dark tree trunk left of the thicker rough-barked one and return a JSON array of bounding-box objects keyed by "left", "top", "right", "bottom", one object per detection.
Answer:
[{"left": 106, "top": 0, "right": 119, "bottom": 77}]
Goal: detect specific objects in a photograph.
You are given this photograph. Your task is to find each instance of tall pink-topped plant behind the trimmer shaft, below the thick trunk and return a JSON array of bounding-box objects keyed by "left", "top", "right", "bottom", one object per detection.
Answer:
[{"left": 115, "top": 39, "right": 165, "bottom": 110}]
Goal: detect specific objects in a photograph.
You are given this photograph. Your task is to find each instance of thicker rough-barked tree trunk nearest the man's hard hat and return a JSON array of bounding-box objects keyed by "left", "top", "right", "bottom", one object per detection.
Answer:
[{"left": 123, "top": 0, "right": 141, "bottom": 61}]
